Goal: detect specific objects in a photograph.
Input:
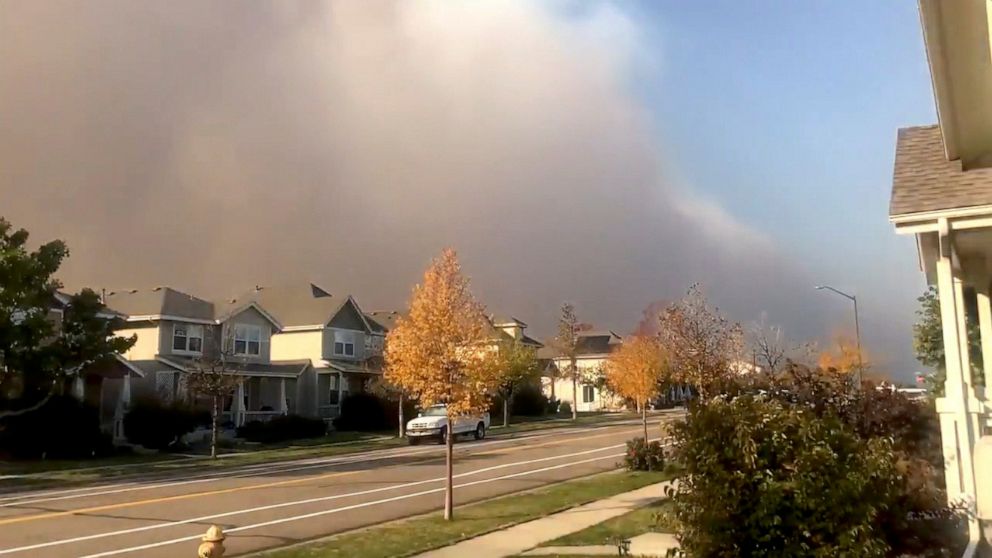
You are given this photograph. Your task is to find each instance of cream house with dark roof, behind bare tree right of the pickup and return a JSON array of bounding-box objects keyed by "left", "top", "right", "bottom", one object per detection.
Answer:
[{"left": 538, "top": 330, "right": 623, "bottom": 411}]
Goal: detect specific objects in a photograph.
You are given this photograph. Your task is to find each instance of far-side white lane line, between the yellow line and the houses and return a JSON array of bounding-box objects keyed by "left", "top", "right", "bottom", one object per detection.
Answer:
[{"left": 0, "top": 429, "right": 591, "bottom": 508}]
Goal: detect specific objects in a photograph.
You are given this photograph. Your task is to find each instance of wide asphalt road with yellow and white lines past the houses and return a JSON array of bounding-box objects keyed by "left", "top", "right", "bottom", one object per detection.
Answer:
[{"left": 0, "top": 416, "right": 676, "bottom": 558}]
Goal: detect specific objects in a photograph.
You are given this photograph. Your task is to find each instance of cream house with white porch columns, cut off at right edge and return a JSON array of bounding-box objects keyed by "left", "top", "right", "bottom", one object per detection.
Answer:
[{"left": 889, "top": 0, "right": 992, "bottom": 557}]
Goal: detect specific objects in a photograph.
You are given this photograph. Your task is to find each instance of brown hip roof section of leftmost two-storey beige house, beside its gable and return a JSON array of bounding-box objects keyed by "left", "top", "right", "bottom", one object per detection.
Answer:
[{"left": 106, "top": 287, "right": 214, "bottom": 323}]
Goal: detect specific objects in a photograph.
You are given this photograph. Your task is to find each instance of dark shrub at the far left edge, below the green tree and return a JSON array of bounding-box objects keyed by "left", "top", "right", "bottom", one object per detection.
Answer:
[{"left": 0, "top": 396, "right": 113, "bottom": 459}]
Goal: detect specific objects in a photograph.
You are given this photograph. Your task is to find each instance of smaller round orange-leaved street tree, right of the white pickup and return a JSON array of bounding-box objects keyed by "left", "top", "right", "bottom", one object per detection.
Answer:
[{"left": 606, "top": 335, "right": 669, "bottom": 443}]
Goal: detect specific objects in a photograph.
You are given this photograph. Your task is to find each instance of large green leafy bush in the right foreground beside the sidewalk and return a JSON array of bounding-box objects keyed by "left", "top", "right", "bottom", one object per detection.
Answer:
[{"left": 673, "top": 394, "right": 909, "bottom": 557}]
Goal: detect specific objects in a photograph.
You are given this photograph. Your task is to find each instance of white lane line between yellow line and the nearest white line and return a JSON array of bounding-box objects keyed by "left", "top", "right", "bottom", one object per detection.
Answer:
[{"left": 0, "top": 444, "right": 640, "bottom": 555}]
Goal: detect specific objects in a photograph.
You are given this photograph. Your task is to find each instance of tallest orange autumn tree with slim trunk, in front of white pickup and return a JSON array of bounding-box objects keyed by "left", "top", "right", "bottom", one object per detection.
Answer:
[{"left": 385, "top": 248, "right": 501, "bottom": 520}]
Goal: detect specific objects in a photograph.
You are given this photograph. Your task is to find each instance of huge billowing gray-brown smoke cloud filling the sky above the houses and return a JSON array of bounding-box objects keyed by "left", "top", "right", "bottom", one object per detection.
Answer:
[{"left": 0, "top": 0, "right": 846, "bottom": 358}]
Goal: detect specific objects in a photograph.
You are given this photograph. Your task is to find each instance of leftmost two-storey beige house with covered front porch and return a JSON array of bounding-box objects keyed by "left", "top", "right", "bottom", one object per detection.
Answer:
[{"left": 105, "top": 287, "right": 314, "bottom": 426}]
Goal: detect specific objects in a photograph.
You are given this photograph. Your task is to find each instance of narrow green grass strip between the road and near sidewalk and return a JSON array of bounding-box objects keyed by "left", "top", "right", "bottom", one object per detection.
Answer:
[{"left": 265, "top": 472, "right": 671, "bottom": 558}]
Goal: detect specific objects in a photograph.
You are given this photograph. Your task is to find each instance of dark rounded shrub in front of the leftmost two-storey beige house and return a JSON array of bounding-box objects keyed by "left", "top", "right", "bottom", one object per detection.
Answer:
[{"left": 124, "top": 399, "right": 210, "bottom": 450}]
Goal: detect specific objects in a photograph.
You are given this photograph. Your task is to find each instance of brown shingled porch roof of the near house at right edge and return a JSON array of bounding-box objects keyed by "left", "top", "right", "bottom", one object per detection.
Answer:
[{"left": 889, "top": 125, "right": 992, "bottom": 217}]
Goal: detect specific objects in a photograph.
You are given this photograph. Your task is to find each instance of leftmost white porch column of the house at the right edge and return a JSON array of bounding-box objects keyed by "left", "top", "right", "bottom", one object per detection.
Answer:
[{"left": 936, "top": 219, "right": 977, "bottom": 506}]
